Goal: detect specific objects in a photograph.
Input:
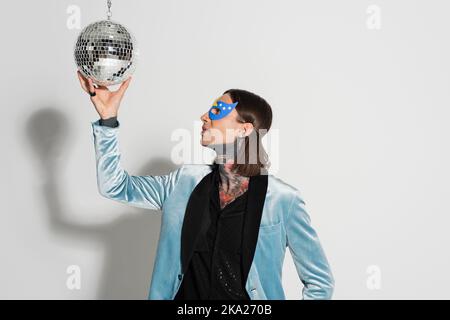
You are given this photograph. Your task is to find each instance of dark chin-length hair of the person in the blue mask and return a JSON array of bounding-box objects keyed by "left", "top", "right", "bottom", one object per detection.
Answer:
[{"left": 223, "top": 89, "right": 272, "bottom": 177}]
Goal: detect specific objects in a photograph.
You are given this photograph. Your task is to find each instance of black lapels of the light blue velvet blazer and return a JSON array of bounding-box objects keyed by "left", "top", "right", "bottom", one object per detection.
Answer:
[{"left": 181, "top": 164, "right": 268, "bottom": 284}]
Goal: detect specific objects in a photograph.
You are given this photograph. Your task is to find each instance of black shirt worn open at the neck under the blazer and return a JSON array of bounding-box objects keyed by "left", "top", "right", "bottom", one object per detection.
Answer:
[{"left": 174, "top": 167, "right": 250, "bottom": 300}]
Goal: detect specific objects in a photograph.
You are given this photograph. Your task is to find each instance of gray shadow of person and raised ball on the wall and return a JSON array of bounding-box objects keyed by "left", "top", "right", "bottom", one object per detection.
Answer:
[{"left": 26, "top": 106, "right": 175, "bottom": 299}]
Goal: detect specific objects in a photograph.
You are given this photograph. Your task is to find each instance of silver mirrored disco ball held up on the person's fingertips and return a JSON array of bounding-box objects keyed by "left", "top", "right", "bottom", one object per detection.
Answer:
[{"left": 74, "top": 20, "right": 138, "bottom": 86}]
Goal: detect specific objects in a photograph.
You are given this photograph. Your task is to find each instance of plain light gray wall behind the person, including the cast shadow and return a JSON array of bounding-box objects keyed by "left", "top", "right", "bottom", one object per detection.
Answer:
[{"left": 0, "top": 0, "right": 450, "bottom": 299}]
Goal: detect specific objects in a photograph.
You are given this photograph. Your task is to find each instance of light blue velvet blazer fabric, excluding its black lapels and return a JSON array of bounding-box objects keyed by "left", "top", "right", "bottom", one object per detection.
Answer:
[{"left": 91, "top": 120, "right": 334, "bottom": 300}]
